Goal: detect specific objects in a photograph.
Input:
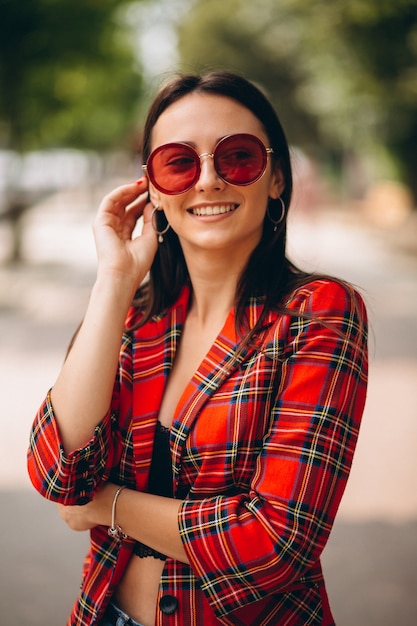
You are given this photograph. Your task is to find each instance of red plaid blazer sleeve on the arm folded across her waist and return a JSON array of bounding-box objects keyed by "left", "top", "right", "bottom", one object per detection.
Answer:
[{"left": 179, "top": 280, "right": 367, "bottom": 616}]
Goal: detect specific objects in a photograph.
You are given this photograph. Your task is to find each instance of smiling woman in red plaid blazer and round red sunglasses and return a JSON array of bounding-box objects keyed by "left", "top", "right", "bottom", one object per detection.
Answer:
[{"left": 29, "top": 72, "right": 367, "bottom": 626}]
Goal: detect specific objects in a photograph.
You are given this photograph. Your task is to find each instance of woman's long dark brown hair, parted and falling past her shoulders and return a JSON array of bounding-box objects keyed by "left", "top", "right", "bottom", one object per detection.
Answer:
[{"left": 135, "top": 71, "right": 334, "bottom": 343}]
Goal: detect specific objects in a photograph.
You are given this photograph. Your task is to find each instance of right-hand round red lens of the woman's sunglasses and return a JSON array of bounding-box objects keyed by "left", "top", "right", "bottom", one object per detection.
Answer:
[{"left": 214, "top": 134, "right": 267, "bottom": 185}]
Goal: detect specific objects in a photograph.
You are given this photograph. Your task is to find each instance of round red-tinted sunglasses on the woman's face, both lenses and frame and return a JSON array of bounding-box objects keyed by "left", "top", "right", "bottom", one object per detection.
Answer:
[{"left": 142, "top": 133, "right": 274, "bottom": 196}]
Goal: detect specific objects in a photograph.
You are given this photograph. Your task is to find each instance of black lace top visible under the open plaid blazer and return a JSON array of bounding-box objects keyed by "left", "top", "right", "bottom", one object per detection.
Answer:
[{"left": 133, "top": 422, "right": 173, "bottom": 561}]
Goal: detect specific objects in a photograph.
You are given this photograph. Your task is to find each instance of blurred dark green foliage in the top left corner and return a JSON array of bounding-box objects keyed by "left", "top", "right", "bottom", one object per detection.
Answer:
[{"left": 0, "top": 0, "right": 142, "bottom": 150}]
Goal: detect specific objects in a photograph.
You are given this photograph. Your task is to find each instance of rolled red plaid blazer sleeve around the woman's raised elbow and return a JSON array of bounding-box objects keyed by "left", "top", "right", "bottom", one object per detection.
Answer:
[{"left": 27, "top": 335, "right": 131, "bottom": 505}]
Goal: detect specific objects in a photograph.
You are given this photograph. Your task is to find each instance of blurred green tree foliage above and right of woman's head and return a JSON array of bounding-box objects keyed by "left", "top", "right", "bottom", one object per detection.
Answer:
[{"left": 178, "top": 0, "right": 417, "bottom": 199}]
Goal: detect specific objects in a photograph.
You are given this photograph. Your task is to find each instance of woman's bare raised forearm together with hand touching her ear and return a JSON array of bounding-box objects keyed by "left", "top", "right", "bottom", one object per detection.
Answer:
[{"left": 51, "top": 178, "right": 158, "bottom": 454}]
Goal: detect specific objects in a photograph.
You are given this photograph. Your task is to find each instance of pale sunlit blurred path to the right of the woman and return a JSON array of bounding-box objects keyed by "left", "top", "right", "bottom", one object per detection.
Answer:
[{"left": 289, "top": 202, "right": 417, "bottom": 520}]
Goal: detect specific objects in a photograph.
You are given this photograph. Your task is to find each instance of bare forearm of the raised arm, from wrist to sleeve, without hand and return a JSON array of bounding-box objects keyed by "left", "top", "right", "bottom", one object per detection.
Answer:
[{"left": 51, "top": 273, "right": 134, "bottom": 452}]
